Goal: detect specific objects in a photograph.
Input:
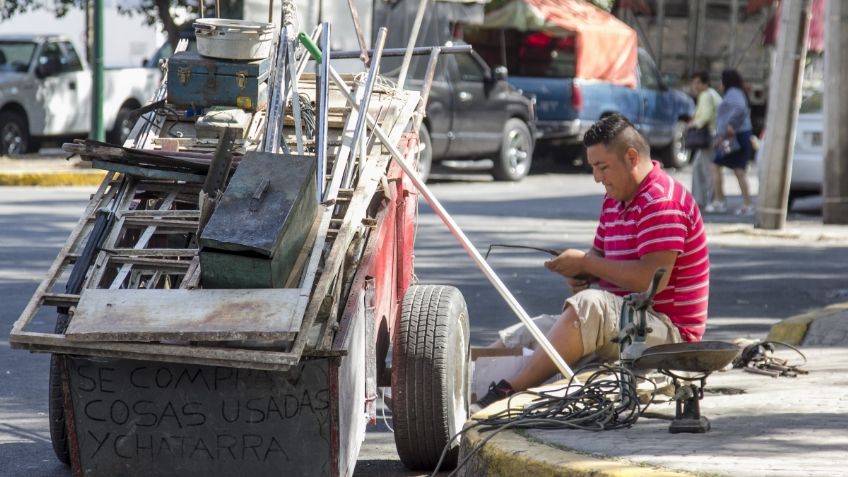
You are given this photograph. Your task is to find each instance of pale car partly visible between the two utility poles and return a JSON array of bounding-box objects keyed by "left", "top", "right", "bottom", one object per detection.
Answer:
[{"left": 789, "top": 92, "right": 824, "bottom": 207}]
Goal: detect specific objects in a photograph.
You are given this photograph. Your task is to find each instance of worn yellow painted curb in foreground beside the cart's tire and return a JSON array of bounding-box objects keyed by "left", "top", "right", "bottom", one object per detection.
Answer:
[{"left": 459, "top": 429, "right": 694, "bottom": 477}]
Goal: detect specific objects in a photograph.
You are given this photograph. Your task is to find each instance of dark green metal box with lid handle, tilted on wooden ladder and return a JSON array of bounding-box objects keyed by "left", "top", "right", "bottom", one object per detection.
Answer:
[{"left": 200, "top": 152, "right": 318, "bottom": 288}]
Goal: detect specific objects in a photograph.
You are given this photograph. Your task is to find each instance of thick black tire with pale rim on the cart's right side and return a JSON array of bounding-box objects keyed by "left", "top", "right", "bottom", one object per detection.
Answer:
[{"left": 392, "top": 285, "right": 470, "bottom": 470}]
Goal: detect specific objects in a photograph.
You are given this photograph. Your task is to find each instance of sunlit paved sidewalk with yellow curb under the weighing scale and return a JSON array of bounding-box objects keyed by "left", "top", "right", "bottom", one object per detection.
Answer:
[{"left": 460, "top": 294, "right": 848, "bottom": 477}]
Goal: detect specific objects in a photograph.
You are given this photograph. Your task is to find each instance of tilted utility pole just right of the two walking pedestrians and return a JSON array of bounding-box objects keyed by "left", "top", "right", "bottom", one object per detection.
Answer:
[{"left": 757, "top": 0, "right": 812, "bottom": 230}]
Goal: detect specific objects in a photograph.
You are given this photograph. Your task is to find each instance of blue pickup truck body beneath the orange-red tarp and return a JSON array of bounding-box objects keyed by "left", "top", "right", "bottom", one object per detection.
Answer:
[{"left": 509, "top": 47, "right": 695, "bottom": 167}]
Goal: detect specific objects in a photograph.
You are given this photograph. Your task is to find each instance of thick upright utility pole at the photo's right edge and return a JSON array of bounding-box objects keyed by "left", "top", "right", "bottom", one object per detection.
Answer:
[{"left": 822, "top": 1, "right": 848, "bottom": 224}]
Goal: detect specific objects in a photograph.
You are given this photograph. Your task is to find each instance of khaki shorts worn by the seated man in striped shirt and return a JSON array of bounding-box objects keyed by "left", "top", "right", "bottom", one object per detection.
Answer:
[{"left": 498, "top": 289, "right": 683, "bottom": 361}]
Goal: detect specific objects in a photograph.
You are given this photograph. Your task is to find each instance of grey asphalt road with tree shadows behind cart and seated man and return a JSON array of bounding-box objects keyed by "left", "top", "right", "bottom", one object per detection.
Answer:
[{"left": 0, "top": 164, "right": 848, "bottom": 477}]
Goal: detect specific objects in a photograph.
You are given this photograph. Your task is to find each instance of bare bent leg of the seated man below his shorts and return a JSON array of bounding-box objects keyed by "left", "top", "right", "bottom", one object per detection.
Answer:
[{"left": 508, "top": 306, "right": 583, "bottom": 391}]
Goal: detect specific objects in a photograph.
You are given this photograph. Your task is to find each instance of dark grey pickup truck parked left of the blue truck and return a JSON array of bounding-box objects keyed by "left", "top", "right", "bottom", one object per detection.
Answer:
[{"left": 400, "top": 42, "right": 535, "bottom": 181}]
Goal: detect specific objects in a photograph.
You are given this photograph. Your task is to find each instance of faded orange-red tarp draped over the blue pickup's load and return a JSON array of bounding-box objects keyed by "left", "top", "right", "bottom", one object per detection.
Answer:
[{"left": 483, "top": 0, "right": 638, "bottom": 88}]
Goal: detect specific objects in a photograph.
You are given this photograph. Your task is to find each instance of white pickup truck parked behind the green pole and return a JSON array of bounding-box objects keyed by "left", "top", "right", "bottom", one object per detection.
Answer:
[{"left": 0, "top": 35, "right": 161, "bottom": 155}]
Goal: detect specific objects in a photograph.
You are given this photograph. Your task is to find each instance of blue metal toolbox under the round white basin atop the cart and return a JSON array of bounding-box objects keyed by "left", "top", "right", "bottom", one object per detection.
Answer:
[{"left": 168, "top": 51, "right": 271, "bottom": 111}]
